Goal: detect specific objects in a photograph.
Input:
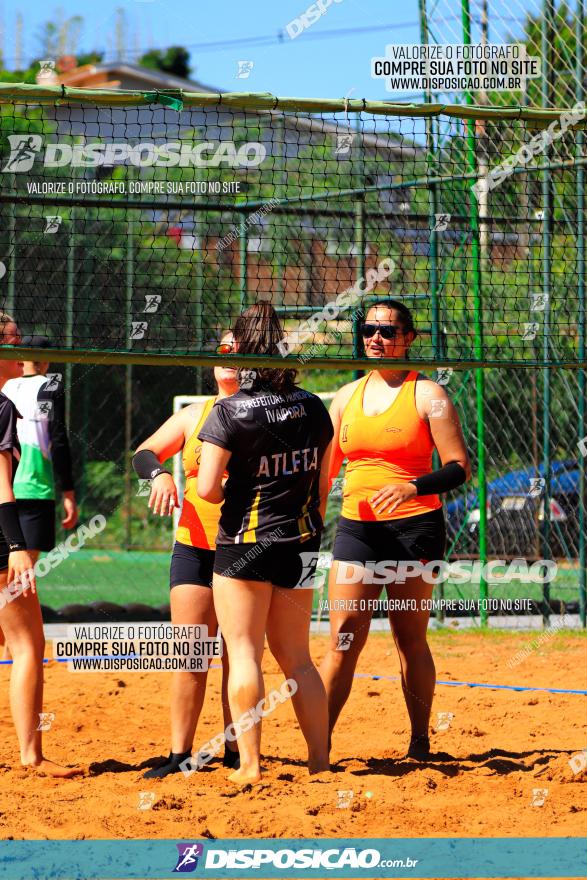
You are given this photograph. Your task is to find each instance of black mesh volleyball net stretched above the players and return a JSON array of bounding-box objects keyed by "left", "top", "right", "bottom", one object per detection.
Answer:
[{"left": 0, "top": 83, "right": 586, "bottom": 368}]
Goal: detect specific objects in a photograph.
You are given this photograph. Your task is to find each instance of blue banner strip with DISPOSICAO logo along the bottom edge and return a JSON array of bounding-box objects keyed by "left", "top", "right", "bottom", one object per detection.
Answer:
[{"left": 0, "top": 837, "right": 587, "bottom": 880}]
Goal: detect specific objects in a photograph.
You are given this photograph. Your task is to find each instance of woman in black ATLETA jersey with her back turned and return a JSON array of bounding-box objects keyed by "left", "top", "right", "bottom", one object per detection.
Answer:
[{"left": 198, "top": 303, "right": 333, "bottom": 785}]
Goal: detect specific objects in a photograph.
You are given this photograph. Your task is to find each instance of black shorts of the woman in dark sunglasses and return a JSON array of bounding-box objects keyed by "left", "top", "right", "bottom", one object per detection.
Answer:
[{"left": 332, "top": 507, "right": 446, "bottom": 565}]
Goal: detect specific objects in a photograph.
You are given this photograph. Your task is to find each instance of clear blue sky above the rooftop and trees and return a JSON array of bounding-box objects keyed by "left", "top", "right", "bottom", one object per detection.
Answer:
[{"left": 0, "top": 0, "right": 552, "bottom": 100}]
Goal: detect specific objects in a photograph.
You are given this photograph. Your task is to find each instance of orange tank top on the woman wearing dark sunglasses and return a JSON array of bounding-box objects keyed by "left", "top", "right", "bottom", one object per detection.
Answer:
[{"left": 338, "top": 370, "right": 442, "bottom": 521}]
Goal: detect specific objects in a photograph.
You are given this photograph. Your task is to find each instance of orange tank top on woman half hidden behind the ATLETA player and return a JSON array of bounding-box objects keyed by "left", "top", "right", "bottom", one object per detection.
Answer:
[{"left": 175, "top": 397, "right": 222, "bottom": 550}]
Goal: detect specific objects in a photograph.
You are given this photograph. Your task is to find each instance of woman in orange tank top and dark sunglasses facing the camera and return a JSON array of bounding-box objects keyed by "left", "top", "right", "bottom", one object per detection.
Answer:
[{"left": 320, "top": 300, "right": 471, "bottom": 759}]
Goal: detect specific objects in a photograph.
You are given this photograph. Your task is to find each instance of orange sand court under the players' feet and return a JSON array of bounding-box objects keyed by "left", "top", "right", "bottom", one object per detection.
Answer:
[{"left": 0, "top": 631, "right": 587, "bottom": 839}]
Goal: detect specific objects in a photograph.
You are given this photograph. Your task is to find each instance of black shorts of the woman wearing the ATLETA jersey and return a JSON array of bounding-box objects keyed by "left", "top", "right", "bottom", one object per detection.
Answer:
[{"left": 214, "top": 535, "right": 320, "bottom": 590}]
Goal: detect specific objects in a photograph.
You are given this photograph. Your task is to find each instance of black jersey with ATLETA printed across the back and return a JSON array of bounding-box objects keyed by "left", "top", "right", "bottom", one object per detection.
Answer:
[{"left": 198, "top": 388, "right": 334, "bottom": 544}]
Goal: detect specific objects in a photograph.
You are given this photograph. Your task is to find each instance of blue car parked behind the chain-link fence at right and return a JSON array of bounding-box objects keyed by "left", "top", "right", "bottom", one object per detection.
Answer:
[{"left": 446, "top": 460, "right": 579, "bottom": 559}]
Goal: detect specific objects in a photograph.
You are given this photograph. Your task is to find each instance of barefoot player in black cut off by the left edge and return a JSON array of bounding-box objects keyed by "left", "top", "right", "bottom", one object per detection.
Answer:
[{"left": 0, "top": 313, "right": 80, "bottom": 778}]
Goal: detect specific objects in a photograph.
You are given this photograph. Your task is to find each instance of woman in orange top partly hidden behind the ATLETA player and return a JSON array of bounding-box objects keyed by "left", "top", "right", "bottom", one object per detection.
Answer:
[{"left": 133, "top": 333, "right": 239, "bottom": 779}]
